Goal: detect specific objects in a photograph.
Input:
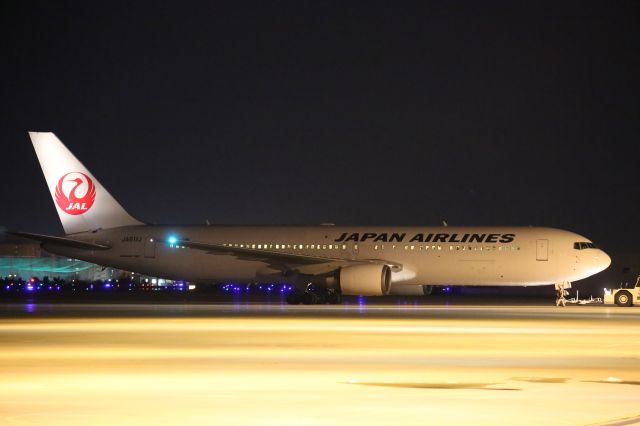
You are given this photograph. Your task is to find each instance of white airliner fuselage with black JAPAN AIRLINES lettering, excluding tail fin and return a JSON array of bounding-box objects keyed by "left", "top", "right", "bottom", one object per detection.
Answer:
[{"left": 45, "top": 225, "right": 611, "bottom": 286}]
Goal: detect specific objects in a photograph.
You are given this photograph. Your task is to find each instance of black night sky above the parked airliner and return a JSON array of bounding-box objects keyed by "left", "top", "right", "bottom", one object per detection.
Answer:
[{"left": 0, "top": 1, "right": 640, "bottom": 251}]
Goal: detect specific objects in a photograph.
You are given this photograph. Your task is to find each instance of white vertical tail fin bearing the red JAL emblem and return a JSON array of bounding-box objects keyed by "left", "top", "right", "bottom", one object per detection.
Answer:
[{"left": 29, "top": 132, "right": 143, "bottom": 234}]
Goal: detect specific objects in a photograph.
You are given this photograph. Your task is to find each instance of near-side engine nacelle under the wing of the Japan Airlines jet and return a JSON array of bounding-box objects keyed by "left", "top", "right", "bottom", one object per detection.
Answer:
[{"left": 340, "top": 265, "right": 391, "bottom": 296}]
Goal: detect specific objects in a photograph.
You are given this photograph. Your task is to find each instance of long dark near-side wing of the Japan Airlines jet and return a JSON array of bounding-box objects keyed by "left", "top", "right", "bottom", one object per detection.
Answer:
[{"left": 170, "top": 240, "right": 402, "bottom": 274}]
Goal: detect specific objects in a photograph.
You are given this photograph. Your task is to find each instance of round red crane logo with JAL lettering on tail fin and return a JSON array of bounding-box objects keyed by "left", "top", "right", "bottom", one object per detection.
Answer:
[{"left": 56, "top": 172, "right": 96, "bottom": 216}]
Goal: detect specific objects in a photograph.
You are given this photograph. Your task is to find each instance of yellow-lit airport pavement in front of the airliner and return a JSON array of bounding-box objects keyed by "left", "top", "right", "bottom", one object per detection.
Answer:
[{"left": 0, "top": 305, "right": 640, "bottom": 426}]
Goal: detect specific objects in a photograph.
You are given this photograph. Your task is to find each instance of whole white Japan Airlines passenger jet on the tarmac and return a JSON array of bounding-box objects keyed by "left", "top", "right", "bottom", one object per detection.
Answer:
[{"left": 9, "top": 132, "right": 611, "bottom": 304}]
